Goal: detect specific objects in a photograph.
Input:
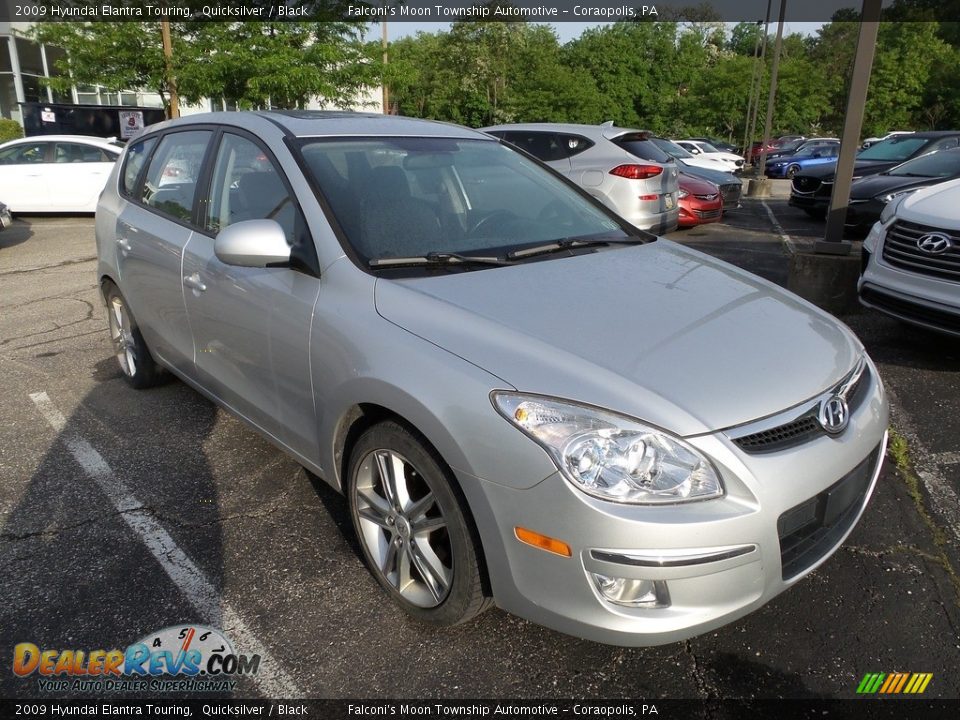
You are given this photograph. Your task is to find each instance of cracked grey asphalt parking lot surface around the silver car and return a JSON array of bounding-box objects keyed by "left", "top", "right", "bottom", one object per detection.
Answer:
[{"left": 0, "top": 199, "right": 960, "bottom": 698}]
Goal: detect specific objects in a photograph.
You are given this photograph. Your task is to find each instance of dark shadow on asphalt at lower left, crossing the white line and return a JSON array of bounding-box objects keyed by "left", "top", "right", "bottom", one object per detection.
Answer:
[{"left": 0, "top": 366, "right": 224, "bottom": 697}]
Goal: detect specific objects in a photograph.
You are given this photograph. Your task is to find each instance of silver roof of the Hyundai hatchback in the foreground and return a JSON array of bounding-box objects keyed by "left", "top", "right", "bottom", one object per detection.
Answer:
[{"left": 147, "top": 110, "right": 489, "bottom": 140}]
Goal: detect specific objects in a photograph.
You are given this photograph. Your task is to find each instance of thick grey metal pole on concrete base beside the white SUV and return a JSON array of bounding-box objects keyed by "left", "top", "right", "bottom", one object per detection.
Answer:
[{"left": 814, "top": 0, "right": 881, "bottom": 255}]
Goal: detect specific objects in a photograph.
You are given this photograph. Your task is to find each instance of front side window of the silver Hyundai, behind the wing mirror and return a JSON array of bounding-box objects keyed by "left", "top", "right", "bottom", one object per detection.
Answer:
[{"left": 204, "top": 133, "right": 298, "bottom": 246}]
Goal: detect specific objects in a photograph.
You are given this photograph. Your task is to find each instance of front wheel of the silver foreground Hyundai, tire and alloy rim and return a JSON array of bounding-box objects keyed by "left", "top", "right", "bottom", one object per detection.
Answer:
[{"left": 347, "top": 421, "right": 491, "bottom": 626}]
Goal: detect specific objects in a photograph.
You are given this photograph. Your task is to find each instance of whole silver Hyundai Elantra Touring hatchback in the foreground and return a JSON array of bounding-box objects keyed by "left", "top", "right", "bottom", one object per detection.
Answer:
[{"left": 96, "top": 112, "right": 888, "bottom": 645}]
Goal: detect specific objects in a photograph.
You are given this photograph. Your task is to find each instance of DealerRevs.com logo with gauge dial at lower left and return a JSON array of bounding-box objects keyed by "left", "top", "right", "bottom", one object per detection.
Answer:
[{"left": 13, "top": 625, "right": 260, "bottom": 691}]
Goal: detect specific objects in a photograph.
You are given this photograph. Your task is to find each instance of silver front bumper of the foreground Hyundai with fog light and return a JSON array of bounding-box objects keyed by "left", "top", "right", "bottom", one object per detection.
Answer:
[{"left": 457, "top": 365, "right": 888, "bottom": 646}]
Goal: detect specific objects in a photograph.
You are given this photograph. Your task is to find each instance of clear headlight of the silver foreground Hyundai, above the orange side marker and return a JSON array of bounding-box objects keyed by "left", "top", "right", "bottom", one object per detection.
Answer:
[{"left": 491, "top": 392, "right": 723, "bottom": 505}]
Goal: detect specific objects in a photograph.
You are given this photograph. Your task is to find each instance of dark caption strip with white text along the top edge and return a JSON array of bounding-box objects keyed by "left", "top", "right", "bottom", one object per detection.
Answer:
[{"left": 0, "top": 0, "right": 960, "bottom": 23}]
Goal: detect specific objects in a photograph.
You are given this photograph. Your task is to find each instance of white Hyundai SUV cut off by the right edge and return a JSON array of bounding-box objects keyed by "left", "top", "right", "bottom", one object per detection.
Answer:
[{"left": 858, "top": 180, "right": 960, "bottom": 335}]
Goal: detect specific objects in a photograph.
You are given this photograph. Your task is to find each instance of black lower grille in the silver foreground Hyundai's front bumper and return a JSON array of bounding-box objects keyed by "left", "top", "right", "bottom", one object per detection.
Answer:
[{"left": 777, "top": 445, "right": 881, "bottom": 580}]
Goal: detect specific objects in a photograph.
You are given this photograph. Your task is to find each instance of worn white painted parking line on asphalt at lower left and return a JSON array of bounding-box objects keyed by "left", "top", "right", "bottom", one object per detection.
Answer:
[{"left": 30, "top": 392, "right": 303, "bottom": 698}]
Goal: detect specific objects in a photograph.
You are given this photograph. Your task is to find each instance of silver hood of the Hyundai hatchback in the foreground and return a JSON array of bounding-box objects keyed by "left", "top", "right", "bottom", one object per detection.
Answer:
[{"left": 375, "top": 240, "right": 862, "bottom": 436}]
